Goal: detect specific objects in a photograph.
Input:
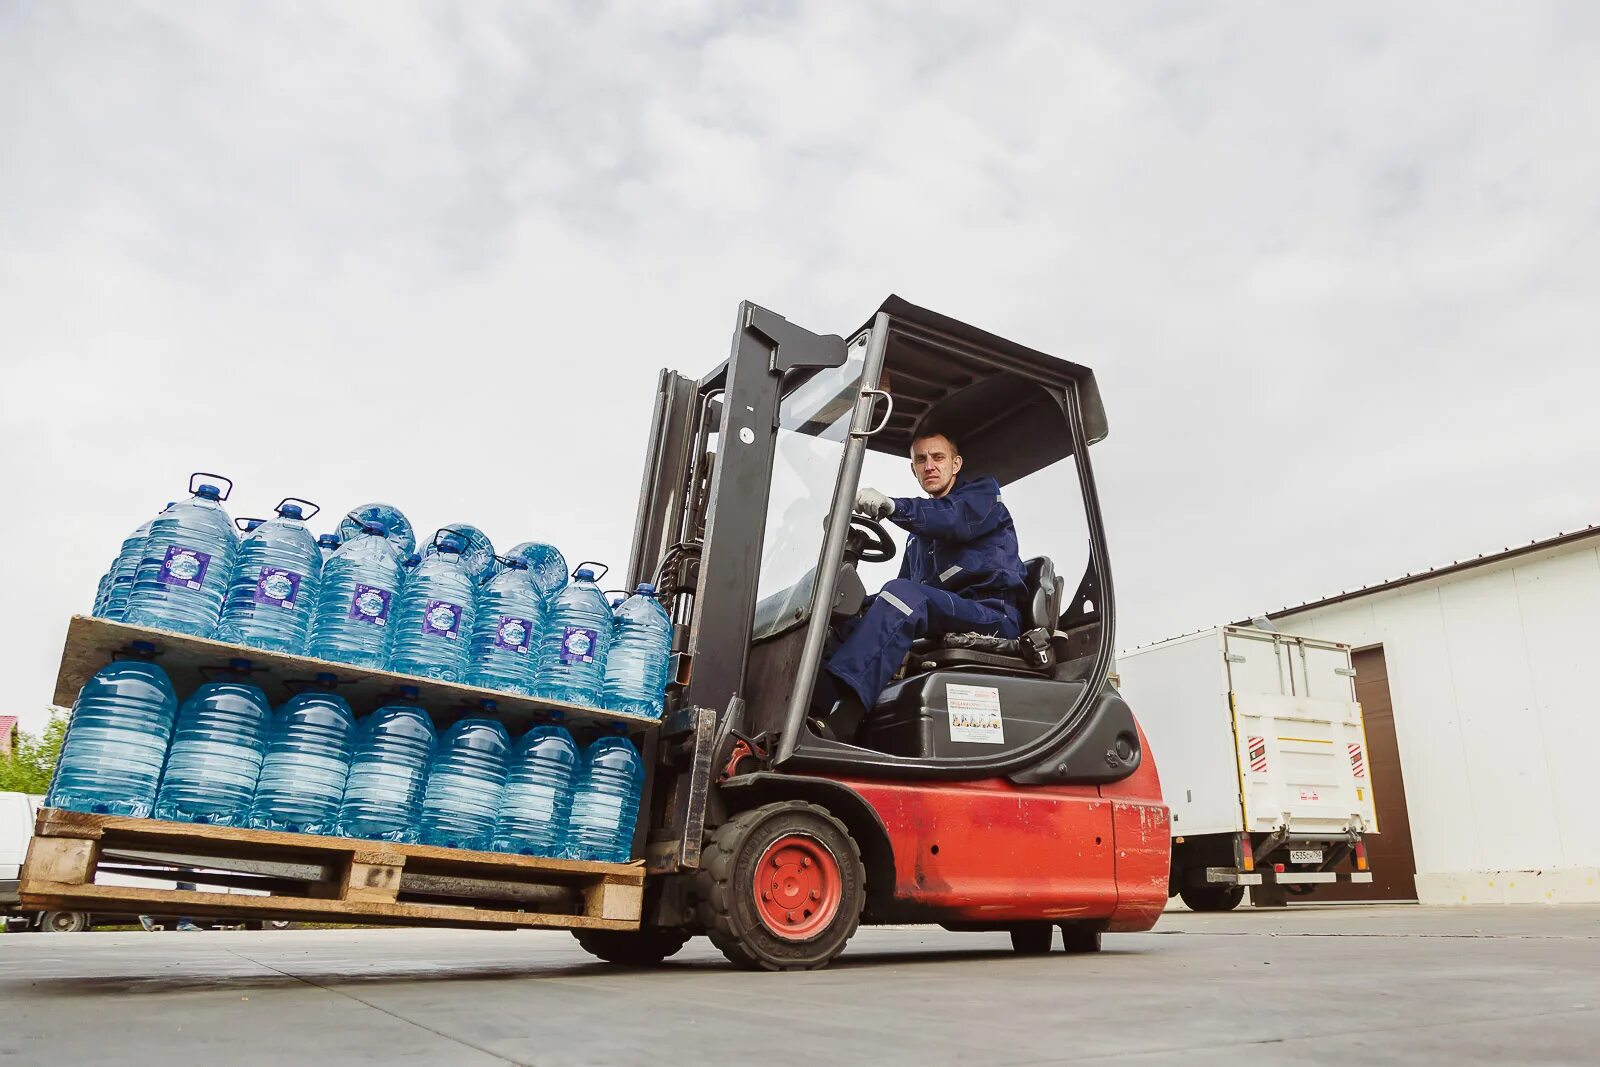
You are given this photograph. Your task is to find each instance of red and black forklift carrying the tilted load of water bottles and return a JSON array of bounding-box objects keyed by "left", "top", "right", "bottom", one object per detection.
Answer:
[{"left": 574, "top": 296, "right": 1170, "bottom": 971}]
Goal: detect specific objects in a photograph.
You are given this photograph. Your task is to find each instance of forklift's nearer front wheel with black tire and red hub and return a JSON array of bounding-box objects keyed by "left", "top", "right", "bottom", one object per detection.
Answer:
[{"left": 694, "top": 800, "right": 867, "bottom": 971}]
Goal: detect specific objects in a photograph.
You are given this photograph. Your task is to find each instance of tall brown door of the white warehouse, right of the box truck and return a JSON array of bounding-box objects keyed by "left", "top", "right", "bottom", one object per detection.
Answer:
[{"left": 1310, "top": 645, "right": 1416, "bottom": 901}]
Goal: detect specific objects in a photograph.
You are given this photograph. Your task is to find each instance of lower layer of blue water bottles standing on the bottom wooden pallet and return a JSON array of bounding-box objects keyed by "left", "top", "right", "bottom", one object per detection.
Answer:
[{"left": 45, "top": 652, "right": 643, "bottom": 862}]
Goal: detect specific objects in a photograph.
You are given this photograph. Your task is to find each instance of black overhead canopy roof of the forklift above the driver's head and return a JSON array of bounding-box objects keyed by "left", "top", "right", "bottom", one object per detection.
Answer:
[{"left": 858, "top": 296, "right": 1107, "bottom": 485}]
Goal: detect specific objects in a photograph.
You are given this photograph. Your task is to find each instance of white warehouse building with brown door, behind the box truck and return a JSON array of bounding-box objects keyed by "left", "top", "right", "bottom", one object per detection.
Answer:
[{"left": 1269, "top": 526, "right": 1600, "bottom": 904}]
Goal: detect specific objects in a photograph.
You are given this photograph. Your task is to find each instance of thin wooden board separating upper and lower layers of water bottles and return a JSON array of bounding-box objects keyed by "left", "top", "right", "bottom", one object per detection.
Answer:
[{"left": 54, "top": 614, "right": 659, "bottom": 736}]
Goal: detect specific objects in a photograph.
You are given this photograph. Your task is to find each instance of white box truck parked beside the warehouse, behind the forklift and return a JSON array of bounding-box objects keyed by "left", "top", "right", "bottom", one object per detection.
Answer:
[{"left": 1117, "top": 625, "right": 1378, "bottom": 912}]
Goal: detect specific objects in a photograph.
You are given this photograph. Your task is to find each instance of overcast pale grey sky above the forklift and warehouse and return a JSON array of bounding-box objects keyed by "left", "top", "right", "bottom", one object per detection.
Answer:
[{"left": 0, "top": 0, "right": 1600, "bottom": 735}]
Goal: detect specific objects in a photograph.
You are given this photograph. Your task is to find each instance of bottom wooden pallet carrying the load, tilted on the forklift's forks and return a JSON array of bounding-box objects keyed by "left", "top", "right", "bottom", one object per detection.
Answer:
[{"left": 21, "top": 808, "right": 645, "bottom": 929}]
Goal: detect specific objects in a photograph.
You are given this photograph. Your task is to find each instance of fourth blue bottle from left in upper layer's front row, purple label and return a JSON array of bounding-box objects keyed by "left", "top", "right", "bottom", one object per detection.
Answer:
[{"left": 389, "top": 530, "right": 477, "bottom": 681}]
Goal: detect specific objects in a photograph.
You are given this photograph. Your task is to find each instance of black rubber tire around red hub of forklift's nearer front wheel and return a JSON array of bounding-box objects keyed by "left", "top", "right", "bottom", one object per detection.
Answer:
[{"left": 694, "top": 800, "right": 867, "bottom": 971}]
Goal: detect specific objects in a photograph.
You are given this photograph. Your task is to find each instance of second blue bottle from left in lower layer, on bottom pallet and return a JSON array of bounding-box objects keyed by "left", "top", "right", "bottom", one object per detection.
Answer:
[{"left": 154, "top": 659, "right": 272, "bottom": 825}]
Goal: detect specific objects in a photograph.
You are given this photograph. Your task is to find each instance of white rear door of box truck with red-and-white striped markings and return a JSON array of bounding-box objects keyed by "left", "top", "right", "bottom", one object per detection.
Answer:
[{"left": 1224, "top": 627, "right": 1378, "bottom": 838}]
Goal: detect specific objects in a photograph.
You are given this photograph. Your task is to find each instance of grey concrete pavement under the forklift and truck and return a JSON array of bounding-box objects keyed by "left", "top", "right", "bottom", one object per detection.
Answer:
[{"left": 0, "top": 905, "right": 1600, "bottom": 1067}]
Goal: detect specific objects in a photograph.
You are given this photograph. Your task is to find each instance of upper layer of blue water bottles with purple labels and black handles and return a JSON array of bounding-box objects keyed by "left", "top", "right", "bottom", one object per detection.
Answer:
[{"left": 84, "top": 474, "right": 672, "bottom": 718}]
